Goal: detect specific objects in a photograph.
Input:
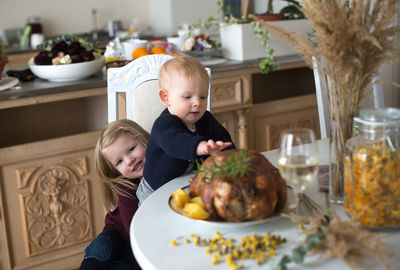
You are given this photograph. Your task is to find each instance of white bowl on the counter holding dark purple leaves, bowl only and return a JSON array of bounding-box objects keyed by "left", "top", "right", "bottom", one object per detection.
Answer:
[{"left": 29, "top": 56, "right": 104, "bottom": 82}]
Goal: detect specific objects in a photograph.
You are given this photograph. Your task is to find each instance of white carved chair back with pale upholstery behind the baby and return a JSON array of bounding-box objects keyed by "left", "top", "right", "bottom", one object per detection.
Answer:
[{"left": 107, "top": 54, "right": 211, "bottom": 132}]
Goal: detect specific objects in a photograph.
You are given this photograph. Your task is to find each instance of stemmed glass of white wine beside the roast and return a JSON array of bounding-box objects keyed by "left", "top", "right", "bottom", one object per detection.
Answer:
[{"left": 278, "top": 128, "right": 319, "bottom": 220}]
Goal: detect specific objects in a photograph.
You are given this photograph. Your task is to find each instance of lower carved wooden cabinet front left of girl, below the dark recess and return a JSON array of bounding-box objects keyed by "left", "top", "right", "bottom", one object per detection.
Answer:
[{"left": 0, "top": 132, "right": 105, "bottom": 270}]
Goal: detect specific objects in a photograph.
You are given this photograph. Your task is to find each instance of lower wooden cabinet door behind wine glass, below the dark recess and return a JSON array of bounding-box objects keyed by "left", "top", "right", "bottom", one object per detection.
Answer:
[{"left": 249, "top": 94, "right": 320, "bottom": 152}]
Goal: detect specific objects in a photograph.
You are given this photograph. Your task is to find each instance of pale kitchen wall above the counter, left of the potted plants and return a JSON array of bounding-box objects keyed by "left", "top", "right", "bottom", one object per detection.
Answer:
[{"left": 0, "top": 0, "right": 217, "bottom": 36}]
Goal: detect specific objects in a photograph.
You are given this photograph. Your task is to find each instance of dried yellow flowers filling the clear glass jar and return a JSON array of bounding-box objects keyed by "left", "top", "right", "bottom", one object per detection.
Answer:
[{"left": 344, "top": 140, "right": 400, "bottom": 228}]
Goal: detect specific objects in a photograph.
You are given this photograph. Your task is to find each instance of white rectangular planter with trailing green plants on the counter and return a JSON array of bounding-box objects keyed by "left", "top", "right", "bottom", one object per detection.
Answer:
[{"left": 218, "top": 0, "right": 311, "bottom": 73}]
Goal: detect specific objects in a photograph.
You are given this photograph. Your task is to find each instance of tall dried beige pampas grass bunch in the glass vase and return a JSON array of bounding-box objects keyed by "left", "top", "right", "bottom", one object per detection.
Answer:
[{"left": 259, "top": 0, "right": 400, "bottom": 196}]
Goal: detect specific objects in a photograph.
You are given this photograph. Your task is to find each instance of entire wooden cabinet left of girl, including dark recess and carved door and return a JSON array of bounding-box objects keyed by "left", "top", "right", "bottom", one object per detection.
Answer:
[{"left": 0, "top": 88, "right": 107, "bottom": 270}]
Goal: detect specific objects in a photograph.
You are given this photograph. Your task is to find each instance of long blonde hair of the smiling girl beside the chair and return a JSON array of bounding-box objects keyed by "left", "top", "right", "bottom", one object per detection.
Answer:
[{"left": 95, "top": 119, "right": 149, "bottom": 211}]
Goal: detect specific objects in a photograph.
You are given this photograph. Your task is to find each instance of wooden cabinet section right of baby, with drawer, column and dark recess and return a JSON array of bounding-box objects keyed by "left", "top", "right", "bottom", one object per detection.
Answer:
[{"left": 211, "top": 65, "right": 319, "bottom": 152}]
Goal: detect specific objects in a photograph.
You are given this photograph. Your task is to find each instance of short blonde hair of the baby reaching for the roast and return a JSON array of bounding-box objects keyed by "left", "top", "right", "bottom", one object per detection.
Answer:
[{"left": 158, "top": 55, "right": 210, "bottom": 89}]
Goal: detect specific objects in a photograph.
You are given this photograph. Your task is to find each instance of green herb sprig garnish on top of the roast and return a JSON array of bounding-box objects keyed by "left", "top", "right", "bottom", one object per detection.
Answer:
[{"left": 195, "top": 150, "right": 253, "bottom": 182}]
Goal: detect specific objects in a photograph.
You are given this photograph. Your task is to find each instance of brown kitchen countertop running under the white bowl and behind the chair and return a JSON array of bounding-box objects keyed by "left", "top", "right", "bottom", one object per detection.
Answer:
[{"left": 0, "top": 55, "right": 305, "bottom": 102}]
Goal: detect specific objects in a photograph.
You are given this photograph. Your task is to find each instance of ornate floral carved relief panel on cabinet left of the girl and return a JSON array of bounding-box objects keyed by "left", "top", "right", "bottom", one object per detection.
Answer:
[{"left": 17, "top": 156, "right": 92, "bottom": 256}]
